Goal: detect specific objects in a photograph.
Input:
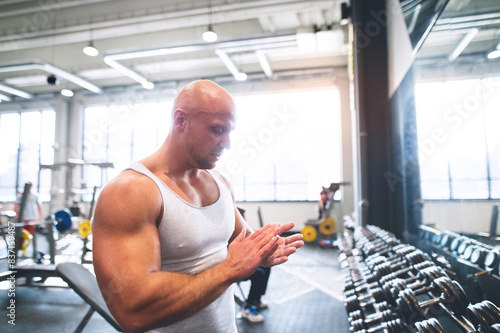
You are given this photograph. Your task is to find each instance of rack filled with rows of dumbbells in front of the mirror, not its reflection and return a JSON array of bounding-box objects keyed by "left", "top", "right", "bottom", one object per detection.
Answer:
[{"left": 337, "top": 225, "right": 500, "bottom": 333}]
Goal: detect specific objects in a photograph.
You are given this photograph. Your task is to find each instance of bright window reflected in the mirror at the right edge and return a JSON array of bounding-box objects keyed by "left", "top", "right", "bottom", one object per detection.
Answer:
[{"left": 415, "top": 78, "right": 500, "bottom": 199}]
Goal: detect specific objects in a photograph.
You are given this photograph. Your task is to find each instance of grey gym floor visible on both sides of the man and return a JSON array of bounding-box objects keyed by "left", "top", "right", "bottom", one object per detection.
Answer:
[{"left": 0, "top": 235, "right": 349, "bottom": 333}]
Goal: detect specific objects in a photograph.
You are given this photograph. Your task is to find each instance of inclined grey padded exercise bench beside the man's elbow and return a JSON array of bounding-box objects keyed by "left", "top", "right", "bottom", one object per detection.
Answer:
[{"left": 56, "top": 262, "right": 123, "bottom": 333}]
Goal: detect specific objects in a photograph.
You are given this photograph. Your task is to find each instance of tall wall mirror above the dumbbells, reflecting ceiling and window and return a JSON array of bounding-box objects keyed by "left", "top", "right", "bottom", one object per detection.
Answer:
[{"left": 414, "top": 0, "right": 500, "bottom": 235}]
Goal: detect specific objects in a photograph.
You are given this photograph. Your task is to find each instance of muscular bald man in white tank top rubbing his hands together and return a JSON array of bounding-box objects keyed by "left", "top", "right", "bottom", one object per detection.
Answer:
[{"left": 93, "top": 80, "right": 303, "bottom": 333}]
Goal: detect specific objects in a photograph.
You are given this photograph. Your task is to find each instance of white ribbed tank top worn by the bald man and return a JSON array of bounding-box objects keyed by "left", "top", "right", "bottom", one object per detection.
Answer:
[{"left": 129, "top": 162, "right": 237, "bottom": 333}]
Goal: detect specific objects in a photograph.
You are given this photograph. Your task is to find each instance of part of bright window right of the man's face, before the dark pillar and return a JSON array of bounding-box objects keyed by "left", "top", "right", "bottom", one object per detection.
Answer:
[{"left": 217, "top": 89, "right": 341, "bottom": 201}]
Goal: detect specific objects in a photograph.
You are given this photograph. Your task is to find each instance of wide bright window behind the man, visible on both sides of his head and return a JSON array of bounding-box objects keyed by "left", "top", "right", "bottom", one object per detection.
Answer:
[{"left": 83, "top": 89, "right": 341, "bottom": 201}]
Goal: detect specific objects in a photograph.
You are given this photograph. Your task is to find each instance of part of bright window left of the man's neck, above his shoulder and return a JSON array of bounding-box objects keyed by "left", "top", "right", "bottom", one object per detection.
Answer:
[{"left": 83, "top": 101, "right": 172, "bottom": 188}]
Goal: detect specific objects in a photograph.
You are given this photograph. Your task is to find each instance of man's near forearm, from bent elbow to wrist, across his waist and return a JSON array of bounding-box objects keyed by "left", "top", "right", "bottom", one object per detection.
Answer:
[{"left": 103, "top": 263, "right": 234, "bottom": 332}]
